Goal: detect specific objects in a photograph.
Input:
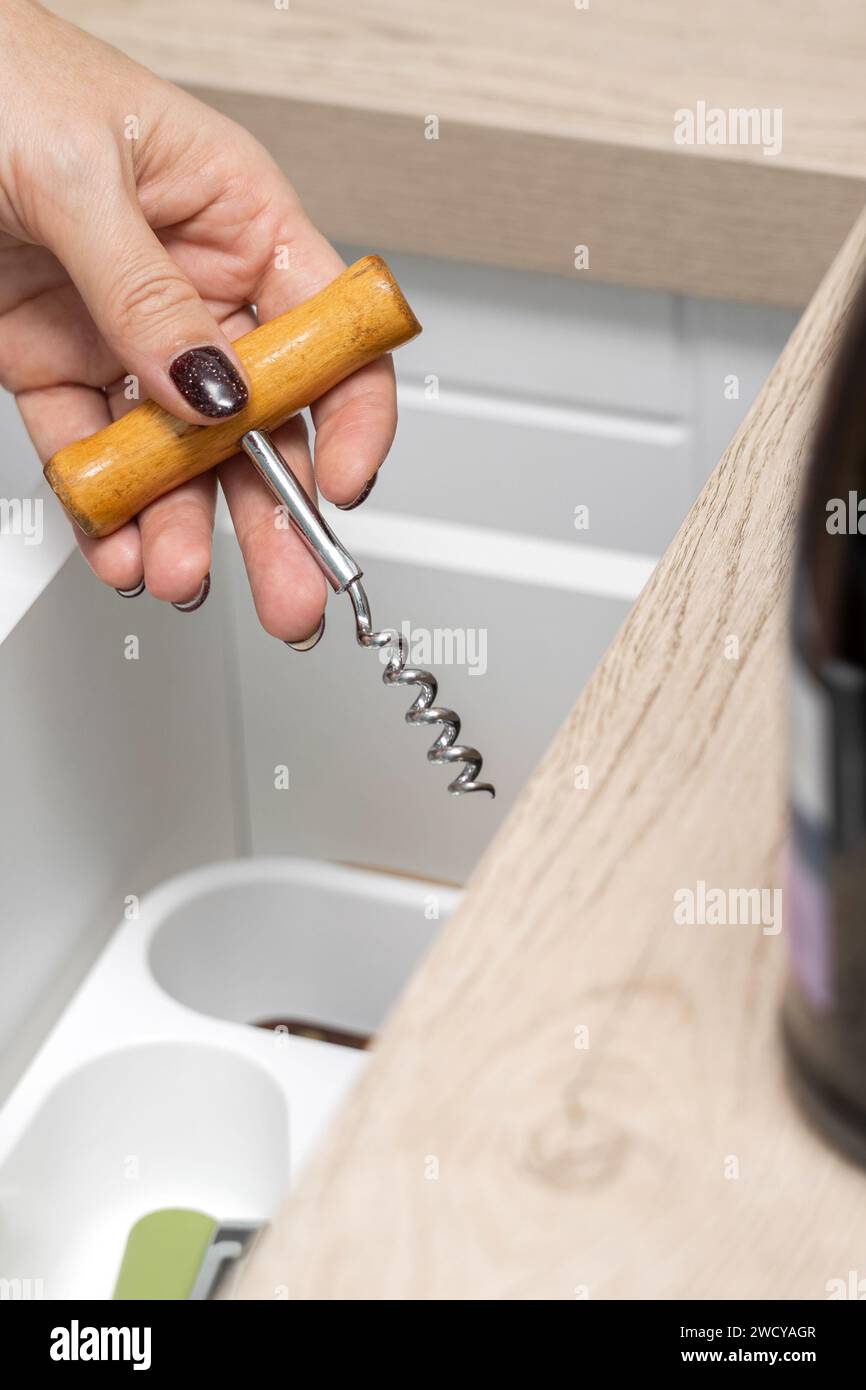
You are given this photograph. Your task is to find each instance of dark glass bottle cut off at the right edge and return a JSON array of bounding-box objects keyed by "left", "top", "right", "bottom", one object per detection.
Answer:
[{"left": 784, "top": 265, "right": 866, "bottom": 1159}]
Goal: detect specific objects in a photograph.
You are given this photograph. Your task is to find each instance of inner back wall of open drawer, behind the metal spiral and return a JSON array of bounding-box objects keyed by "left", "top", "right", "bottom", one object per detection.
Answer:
[{"left": 220, "top": 530, "right": 630, "bottom": 883}]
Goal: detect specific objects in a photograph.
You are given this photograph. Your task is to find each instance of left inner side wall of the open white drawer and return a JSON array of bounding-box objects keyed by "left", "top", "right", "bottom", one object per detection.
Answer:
[{"left": 0, "top": 555, "right": 238, "bottom": 1094}]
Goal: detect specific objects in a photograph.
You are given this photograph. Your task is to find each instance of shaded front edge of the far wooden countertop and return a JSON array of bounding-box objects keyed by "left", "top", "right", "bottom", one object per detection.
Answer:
[{"left": 189, "top": 85, "right": 866, "bottom": 306}]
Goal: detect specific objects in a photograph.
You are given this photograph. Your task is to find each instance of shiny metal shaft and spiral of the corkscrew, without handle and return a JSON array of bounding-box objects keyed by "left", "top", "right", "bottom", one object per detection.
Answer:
[{"left": 240, "top": 430, "right": 496, "bottom": 796}]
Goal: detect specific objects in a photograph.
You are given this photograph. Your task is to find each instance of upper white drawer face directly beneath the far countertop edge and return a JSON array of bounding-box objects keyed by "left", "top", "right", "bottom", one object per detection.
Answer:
[{"left": 343, "top": 249, "right": 688, "bottom": 417}]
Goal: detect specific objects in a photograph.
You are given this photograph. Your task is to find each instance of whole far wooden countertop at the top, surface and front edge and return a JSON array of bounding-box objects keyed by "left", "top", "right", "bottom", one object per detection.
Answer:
[{"left": 50, "top": 0, "right": 866, "bottom": 304}]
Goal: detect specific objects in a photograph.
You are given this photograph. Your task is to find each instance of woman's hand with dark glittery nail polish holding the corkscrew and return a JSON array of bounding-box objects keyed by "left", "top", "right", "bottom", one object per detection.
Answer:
[{"left": 0, "top": 0, "right": 396, "bottom": 641}]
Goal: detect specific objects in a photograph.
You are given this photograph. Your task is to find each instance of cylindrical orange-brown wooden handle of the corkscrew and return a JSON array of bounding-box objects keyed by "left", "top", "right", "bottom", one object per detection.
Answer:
[{"left": 44, "top": 256, "right": 421, "bottom": 537}]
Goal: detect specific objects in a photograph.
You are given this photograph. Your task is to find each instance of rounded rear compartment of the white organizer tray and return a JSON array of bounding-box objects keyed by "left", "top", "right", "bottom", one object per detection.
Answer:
[{"left": 150, "top": 865, "right": 441, "bottom": 1036}]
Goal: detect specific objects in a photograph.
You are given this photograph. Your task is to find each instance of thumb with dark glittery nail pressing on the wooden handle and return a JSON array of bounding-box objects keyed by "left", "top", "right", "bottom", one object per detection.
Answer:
[{"left": 50, "top": 189, "right": 249, "bottom": 424}]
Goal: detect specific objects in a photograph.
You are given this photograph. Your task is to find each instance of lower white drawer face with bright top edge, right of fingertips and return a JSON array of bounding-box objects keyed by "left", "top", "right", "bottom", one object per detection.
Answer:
[{"left": 371, "top": 386, "right": 694, "bottom": 555}]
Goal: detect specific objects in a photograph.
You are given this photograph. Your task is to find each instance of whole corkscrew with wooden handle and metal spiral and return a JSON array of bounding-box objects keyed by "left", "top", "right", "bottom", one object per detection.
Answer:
[{"left": 44, "top": 256, "right": 495, "bottom": 796}]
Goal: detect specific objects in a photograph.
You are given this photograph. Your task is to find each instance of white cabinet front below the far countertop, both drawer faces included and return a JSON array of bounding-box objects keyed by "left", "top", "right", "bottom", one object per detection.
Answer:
[{"left": 343, "top": 249, "right": 796, "bottom": 553}]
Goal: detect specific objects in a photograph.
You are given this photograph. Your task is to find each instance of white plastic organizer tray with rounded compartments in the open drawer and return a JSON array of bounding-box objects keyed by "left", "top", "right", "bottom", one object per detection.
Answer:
[{"left": 0, "top": 859, "right": 457, "bottom": 1298}]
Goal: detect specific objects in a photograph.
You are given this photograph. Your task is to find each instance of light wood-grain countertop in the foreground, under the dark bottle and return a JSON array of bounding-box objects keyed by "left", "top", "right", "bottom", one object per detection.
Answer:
[{"left": 242, "top": 208, "right": 866, "bottom": 1300}]
